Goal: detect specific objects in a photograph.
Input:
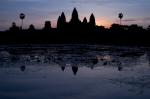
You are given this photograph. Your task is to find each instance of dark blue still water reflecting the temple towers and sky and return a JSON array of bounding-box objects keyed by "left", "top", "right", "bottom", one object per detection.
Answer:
[{"left": 0, "top": 44, "right": 150, "bottom": 99}]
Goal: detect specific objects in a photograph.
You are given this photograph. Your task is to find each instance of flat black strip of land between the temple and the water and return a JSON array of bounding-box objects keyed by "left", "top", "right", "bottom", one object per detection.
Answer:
[{"left": 0, "top": 30, "right": 150, "bottom": 46}]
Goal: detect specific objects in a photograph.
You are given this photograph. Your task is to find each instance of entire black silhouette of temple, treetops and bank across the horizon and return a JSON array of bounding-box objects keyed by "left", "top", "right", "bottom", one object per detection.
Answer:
[{"left": 0, "top": 8, "right": 150, "bottom": 46}]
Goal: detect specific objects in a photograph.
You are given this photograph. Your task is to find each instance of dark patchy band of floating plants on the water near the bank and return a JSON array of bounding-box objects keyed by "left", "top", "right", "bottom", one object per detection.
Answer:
[{"left": 0, "top": 46, "right": 146, "bottom": 70}]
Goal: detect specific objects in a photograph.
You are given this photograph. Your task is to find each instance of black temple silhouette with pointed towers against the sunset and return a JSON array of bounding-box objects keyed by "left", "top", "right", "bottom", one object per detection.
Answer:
[{"left": 57, "top": 8, "right": 96, "bottom": 33}]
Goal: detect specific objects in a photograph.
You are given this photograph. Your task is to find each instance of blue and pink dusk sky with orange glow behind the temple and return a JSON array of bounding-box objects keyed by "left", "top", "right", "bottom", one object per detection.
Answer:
[{"left": 0, "top": 0, "right": 150, "bottom": 31}]
